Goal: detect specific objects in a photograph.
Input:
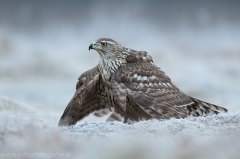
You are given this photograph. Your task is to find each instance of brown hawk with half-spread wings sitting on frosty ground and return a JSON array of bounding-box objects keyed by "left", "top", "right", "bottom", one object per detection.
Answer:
[{"left": 58, "top": 38, "right": 227, "bottom": 126}]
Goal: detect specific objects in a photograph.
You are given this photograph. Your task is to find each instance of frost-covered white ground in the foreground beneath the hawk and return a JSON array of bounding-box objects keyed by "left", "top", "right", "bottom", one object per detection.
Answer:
[{"left": 0, "top": 98, "right": 240, "bottom": 159}]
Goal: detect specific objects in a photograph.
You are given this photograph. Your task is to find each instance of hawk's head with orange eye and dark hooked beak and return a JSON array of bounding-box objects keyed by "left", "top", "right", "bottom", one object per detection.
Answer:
[{"left": 89, "top": 38, "right": 122, "bottom": 59}]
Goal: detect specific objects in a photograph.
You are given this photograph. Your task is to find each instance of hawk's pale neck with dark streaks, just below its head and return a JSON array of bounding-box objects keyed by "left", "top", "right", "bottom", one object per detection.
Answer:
[{"left": 98, "top": 57, "right": 126, "bottom": 81}]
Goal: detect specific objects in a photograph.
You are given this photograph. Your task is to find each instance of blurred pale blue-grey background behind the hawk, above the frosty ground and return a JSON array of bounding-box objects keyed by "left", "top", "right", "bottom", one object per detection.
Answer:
[{"left": 0, "top": 0, "right": 240, "bottom": 117}]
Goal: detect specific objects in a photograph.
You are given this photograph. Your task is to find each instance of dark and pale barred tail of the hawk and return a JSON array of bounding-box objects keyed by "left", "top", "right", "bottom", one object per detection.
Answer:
[{"left": 187, "top": 97, "right": 228, "bottom": 116}]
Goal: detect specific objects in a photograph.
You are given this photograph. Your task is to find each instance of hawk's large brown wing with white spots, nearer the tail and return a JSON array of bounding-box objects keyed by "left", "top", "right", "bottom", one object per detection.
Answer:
[{"left": 112, "top": 62, "right": 193, "bottom": 119}]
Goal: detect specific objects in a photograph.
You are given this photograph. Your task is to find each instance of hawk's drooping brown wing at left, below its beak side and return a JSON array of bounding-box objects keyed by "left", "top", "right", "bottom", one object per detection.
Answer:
[{"left": 58, "top": 67, "right": 107, "bottom": 126}]
